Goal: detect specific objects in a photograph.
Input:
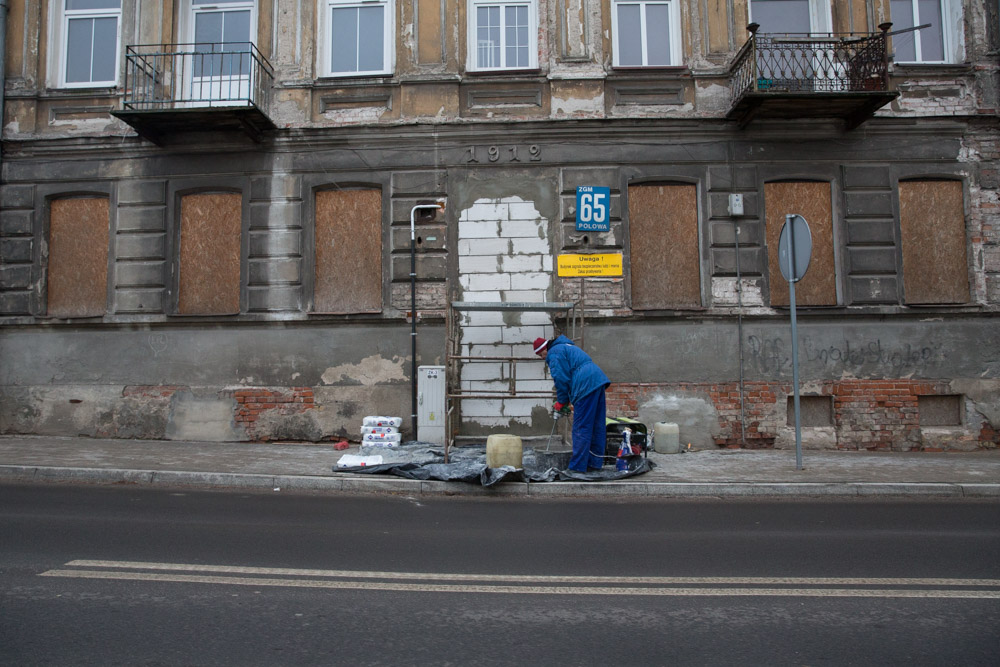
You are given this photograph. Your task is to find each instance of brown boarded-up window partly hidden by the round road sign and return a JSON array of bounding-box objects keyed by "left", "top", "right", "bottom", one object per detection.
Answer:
[{"left": 764, "top": 182, "right": 837, "bottom": 306}]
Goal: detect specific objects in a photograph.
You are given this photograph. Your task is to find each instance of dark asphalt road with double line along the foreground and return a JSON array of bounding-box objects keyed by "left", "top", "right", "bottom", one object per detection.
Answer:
[{"left": 0, "top": 485, "right": 1000, "bottom": 665}]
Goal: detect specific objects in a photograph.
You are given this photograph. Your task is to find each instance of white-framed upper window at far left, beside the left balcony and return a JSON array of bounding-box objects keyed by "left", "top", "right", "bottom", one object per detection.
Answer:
[{"left": 53, "top": 0, "right": 122, "bottom": 88}]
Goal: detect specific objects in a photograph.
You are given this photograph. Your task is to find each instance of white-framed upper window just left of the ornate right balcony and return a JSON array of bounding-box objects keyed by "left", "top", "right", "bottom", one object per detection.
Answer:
[{"left": 611, "top": 0, "right": 682, "bottom": 67}]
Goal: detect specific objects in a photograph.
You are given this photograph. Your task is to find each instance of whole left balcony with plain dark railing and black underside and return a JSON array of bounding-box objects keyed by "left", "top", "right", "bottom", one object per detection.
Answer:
[{"left": 111, "top": 42, "right": 275, "bottom": 144}]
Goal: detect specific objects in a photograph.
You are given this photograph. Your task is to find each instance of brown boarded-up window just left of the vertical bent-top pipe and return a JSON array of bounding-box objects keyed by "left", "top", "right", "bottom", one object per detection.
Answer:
[{"left": 313, "top": 190, "right": 382, "bottom": 313}]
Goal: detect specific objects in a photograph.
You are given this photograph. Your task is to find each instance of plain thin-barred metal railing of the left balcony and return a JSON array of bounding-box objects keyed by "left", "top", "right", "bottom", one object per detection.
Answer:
[{"left": 123, "top": 42, "right": 274, "bottom": 114}]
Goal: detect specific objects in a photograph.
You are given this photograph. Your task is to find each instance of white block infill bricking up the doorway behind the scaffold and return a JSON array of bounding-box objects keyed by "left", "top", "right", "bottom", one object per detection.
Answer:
[{"left": 458, "top": 197, "right": 554, "bottom": 428}]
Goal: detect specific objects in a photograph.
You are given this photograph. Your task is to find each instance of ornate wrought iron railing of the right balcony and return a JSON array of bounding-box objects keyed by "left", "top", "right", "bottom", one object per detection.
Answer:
[{"left": 730, "top": 23, "right": 889, "bottom": 104}]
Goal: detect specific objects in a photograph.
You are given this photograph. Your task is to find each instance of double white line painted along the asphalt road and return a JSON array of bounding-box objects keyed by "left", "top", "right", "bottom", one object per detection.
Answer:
[{"left": 40, "top": 560, "right": 1000, "bottom": 600}]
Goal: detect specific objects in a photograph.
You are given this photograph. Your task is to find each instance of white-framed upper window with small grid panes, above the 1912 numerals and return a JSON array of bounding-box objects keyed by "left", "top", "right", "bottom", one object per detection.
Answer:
[{"left": 468, "top": 0, "right": 538, "bottom": 71}]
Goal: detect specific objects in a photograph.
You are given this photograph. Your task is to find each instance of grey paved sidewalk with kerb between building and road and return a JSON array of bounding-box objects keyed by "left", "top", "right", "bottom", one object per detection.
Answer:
[{"left": 0, "top": 436, "right": 1000, "bottom": 498}]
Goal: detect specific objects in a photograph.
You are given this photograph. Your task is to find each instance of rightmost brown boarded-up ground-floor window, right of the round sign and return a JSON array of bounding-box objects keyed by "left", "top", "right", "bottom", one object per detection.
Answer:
[{"left": 899, "top": 181, "right": 969, "bottom": 303}]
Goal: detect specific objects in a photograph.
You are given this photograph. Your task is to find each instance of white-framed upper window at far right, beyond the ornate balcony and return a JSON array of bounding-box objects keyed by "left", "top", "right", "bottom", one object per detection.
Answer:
[{"left": 889, "top": 0, "right": 962, "bottom": 63}]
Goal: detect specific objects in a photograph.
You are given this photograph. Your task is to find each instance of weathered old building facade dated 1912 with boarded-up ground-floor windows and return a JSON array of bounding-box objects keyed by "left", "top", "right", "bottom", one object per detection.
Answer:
[{"left": 0, "top": 0, "right": 1000, "bottom": 450}]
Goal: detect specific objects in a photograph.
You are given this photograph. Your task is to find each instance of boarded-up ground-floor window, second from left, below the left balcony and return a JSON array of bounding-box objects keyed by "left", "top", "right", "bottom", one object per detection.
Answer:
[{"left": 177, "top": 192, "right": 243, "bottom": 315}]
